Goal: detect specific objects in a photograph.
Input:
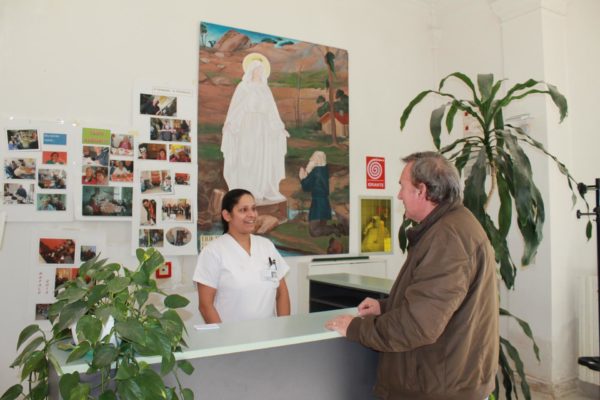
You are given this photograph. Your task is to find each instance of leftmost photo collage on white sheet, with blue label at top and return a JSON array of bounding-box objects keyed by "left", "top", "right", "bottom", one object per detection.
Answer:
[{"left": 0, "top": 121, "right": 73, "bottom": 221}]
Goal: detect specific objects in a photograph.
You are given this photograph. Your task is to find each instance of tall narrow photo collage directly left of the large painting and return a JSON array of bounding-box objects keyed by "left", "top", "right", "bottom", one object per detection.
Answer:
[{"left": 131, "top": 83, "right": 197, "bottom": 255}]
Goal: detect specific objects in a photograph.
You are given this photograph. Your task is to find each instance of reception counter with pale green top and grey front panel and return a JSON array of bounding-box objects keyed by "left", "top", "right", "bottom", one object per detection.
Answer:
[{"left": 54, "top": 309, "right": 377, "bottom": 400}]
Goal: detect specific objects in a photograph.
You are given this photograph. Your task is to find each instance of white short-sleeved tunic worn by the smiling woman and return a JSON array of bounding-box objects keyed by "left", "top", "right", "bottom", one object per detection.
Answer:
[{"left": 193, "top": 234, "right": 290, "bottom": 322}]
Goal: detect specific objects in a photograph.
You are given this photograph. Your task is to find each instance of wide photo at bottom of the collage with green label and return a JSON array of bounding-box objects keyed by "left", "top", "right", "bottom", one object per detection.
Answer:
[{"left": 81, "top": 186, "right": 133, "bottom": 218}]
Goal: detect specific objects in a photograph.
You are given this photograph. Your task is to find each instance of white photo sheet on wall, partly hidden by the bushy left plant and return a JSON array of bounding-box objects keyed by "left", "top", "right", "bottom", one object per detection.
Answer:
[{"left": 30, "top": 230, "right": 106, "bottom": 321}]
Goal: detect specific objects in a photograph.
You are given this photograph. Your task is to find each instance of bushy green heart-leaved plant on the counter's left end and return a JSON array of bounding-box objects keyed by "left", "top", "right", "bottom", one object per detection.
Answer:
[{"left": 1, "top": 248, "right": 194, "bottom": 400}]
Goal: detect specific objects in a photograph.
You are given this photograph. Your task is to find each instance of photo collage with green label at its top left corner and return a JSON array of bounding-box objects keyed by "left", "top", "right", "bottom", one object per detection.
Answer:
[{"left": 79, "top": 128, "right": 134, "bottom": 220}]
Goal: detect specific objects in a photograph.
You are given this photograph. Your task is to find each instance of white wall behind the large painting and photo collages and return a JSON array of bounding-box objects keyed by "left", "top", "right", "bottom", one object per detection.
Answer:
[{"left": 0, "top": 0, "right": 433, "bottom": 392}]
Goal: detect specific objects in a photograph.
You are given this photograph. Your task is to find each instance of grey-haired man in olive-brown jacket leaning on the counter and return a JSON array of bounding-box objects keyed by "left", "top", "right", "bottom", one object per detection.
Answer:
[{"left": 326, "top": 152, "right": 499, "bottom": 400}]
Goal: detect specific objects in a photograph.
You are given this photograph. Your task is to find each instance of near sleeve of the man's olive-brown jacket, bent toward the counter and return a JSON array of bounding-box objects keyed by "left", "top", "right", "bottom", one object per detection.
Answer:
[{"left": 347, "top": 229, "right": 472, "bottom": 352}]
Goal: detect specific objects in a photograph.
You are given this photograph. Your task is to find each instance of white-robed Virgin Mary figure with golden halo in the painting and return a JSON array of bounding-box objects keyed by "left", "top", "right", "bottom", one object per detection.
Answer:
[{"left": 221, "top": 53, "right": 289, "bottom": 201}]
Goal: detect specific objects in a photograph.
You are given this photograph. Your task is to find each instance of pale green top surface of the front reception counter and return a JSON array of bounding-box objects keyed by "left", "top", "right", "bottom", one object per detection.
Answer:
[{"left": 54, "top": 308, "right": 357, "bottom": 373}]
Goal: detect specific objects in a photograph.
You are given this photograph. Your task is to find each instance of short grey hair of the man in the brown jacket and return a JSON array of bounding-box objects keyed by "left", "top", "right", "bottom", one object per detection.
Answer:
[{"left": 402, "top": 151, "right": 461, "bottom": 204}]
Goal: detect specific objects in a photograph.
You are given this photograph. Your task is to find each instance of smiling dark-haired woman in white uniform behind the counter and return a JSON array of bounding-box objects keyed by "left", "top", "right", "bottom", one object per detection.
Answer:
[{"left": 193, "top": 189, "right": 290, "bottom": 323}]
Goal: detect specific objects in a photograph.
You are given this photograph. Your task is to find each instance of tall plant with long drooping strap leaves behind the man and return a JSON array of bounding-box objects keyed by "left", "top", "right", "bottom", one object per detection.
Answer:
[{"left": 400, "top": 72, "right": 591, "bottom": 399}]
